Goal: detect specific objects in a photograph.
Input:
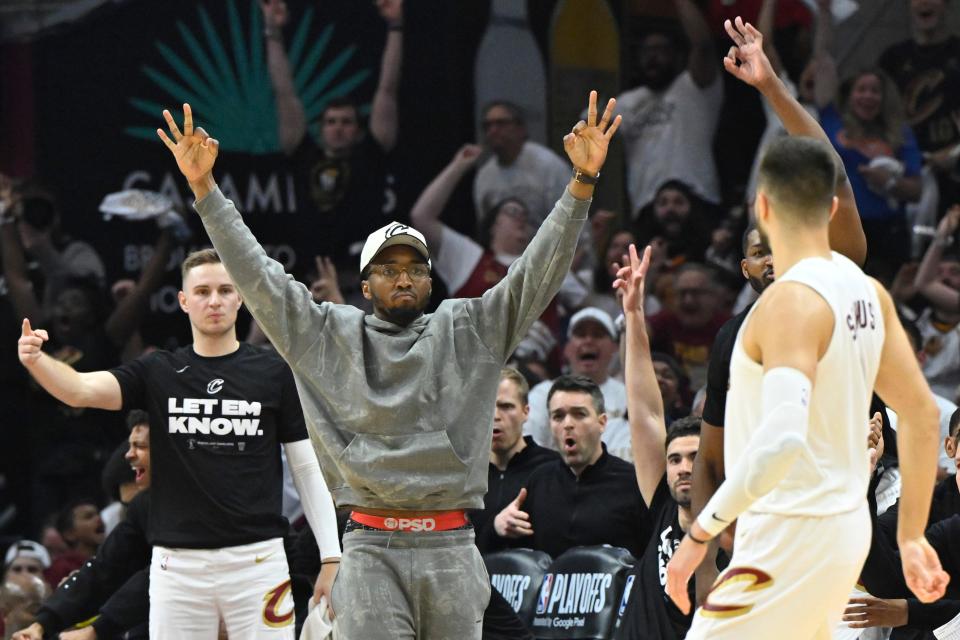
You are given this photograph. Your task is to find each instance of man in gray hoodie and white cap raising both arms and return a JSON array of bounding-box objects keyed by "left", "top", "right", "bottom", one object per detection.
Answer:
[{"left": 157, "top": 92, "right": 620, "bottom": 640}]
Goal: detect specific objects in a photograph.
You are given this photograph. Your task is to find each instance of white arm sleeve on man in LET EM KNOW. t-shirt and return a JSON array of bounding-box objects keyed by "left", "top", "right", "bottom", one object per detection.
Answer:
[{"left": 283, "top": 440, "right": 340, "bottom": 560}]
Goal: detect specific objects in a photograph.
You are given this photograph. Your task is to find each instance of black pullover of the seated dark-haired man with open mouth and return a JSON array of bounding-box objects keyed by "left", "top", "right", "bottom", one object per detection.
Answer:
[{"left": 500, "top": 446, "right": 650, "bottom": 558}]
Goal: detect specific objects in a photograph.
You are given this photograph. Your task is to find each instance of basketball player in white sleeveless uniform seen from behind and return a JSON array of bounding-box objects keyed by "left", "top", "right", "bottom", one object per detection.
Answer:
[{"left": 667, "top": 18, "right": 949, "bottom": 640}]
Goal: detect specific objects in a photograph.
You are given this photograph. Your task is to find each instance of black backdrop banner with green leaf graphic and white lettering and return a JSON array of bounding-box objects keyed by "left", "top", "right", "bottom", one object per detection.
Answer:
[{"left": 32, "top": 0, "right": 485, "bottom": 346}]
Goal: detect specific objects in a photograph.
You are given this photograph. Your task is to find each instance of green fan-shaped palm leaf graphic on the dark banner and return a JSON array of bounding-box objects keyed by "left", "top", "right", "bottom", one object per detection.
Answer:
[{"left": 130, "top": 0, "right": 372, "bottom": 154}]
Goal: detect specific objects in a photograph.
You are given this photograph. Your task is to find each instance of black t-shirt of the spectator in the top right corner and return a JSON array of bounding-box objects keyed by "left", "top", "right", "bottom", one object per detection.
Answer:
[{"left": 880, "top": 36, "right": 960, "bottom": 151}]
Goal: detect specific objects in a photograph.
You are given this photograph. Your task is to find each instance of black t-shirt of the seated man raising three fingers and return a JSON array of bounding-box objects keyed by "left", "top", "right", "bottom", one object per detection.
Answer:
[{"left": 616, "top": 475, "right": 696, "bottom": 640}]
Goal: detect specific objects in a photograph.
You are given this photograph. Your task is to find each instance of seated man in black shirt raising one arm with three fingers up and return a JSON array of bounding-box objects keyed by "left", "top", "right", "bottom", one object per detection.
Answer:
[{"left": 614, "top": 245, "right": 700, "bottom": 640}]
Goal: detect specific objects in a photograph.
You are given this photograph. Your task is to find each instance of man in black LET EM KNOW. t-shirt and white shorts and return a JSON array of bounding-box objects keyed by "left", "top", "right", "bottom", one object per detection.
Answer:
[{"left": 19, "top": 249, "right": 340, "bottom": 640}]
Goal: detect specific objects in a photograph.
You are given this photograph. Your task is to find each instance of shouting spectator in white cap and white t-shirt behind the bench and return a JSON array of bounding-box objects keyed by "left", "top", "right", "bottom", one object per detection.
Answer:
[{"left": 523, "top": 307, "right": 630, "bottom": 458}]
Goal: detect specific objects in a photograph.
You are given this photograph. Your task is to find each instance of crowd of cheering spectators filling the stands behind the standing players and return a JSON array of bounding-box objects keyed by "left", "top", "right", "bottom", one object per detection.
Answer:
[{"left": 0, "top": 0, "right": 960, "bottom": 638}]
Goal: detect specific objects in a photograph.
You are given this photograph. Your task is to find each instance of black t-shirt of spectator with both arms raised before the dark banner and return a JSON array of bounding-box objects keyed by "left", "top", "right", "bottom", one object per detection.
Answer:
[{"left": 291, "top": 135, "right": 394, "bottom": 269}]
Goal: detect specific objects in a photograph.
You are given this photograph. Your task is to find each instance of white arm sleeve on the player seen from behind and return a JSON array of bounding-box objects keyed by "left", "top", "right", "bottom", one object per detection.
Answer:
[{"left": 697, "top": 367, "right": 813, "bottom": 537}]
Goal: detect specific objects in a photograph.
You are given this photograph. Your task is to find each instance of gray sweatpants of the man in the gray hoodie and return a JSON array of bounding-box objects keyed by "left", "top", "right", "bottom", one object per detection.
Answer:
[{"left": 331, "top": 530, "right": 490, "bottom": 640}]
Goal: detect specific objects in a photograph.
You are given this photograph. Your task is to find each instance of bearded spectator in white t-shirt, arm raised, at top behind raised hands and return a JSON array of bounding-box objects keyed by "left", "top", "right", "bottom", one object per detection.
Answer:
[{"left": 617, "top": 0, "right": 723, "bottom": 215}]
